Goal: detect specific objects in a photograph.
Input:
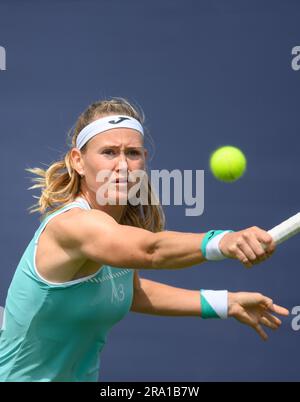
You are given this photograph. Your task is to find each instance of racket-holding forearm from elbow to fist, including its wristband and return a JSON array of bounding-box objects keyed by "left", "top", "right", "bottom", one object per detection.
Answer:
[{"left": 151, "top": 226, "right": 275, "bottom": 269}]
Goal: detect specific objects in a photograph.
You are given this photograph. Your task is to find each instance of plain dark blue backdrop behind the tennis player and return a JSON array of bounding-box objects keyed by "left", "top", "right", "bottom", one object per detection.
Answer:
[{"left": 0, "top": 0, "right": 300, "bottom": 381}]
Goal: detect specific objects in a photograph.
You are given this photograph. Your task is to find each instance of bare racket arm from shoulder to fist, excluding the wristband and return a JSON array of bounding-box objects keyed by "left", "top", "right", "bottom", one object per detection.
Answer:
[{"left": 53, "top": 210, "right": 275, "bottom": 269}]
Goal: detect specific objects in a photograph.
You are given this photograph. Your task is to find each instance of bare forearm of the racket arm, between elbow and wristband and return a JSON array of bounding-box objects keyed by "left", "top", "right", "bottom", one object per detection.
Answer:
[{"left": 152, "top": 231, "right": 205, "bottom": 269}]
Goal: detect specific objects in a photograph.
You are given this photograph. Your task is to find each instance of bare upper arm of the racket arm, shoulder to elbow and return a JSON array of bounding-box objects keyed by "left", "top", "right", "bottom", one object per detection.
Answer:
[{"left": 56, "top": 210, "right": 155, "bottom": 268}]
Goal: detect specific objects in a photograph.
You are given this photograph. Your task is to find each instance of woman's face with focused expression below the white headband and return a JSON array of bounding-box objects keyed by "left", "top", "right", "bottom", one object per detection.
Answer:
[{"left": 75, "top": 128, "right": 147, "bottom": 205}]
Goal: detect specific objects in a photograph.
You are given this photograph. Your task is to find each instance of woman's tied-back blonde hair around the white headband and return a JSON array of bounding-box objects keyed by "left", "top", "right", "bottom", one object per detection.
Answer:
[{"left": 25, "top": 98, "right": 165, "bottom": 232}]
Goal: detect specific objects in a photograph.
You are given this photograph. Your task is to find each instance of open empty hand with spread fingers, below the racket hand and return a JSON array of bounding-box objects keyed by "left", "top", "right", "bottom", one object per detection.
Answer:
[{"left": 228, "top": 292, "right": 289, "bottom": 341}]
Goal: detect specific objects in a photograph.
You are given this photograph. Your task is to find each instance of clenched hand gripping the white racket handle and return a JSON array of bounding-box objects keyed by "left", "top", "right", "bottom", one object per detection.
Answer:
[{"left": 219, "top": 226, "right": 275, "bottom": 268}]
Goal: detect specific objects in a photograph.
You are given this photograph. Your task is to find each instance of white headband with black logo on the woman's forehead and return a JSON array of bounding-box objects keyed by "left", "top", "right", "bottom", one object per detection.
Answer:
[{"left": 76, "top": 115, "right": 144, "bottom": 149}]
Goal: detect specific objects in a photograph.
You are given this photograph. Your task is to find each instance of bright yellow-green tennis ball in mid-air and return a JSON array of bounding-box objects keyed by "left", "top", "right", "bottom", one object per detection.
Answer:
[{"left": 209, "top": 145, "right": 247, "bottom": 182}]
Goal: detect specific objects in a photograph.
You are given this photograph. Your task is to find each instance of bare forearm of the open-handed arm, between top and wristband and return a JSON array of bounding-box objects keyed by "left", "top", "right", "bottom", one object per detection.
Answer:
[{"left": 131, "top": 278, "right": 201, "bottom": 317}]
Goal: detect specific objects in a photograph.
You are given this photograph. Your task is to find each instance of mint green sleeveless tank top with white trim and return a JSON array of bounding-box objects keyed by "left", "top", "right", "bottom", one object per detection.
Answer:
[{"left": 0, "top": 197, "right": 134, "bottom": 382}]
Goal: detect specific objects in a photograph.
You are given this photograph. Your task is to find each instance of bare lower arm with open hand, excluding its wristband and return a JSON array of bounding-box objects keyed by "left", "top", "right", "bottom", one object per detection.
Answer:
[{"left": 131, "top": 271, "right": 289, "bottom": 340}]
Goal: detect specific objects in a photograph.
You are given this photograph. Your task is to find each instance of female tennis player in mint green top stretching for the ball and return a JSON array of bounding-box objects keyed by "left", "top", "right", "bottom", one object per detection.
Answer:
[{"left": 0, "top": 98, "right": 288, "bottom": 381}]
